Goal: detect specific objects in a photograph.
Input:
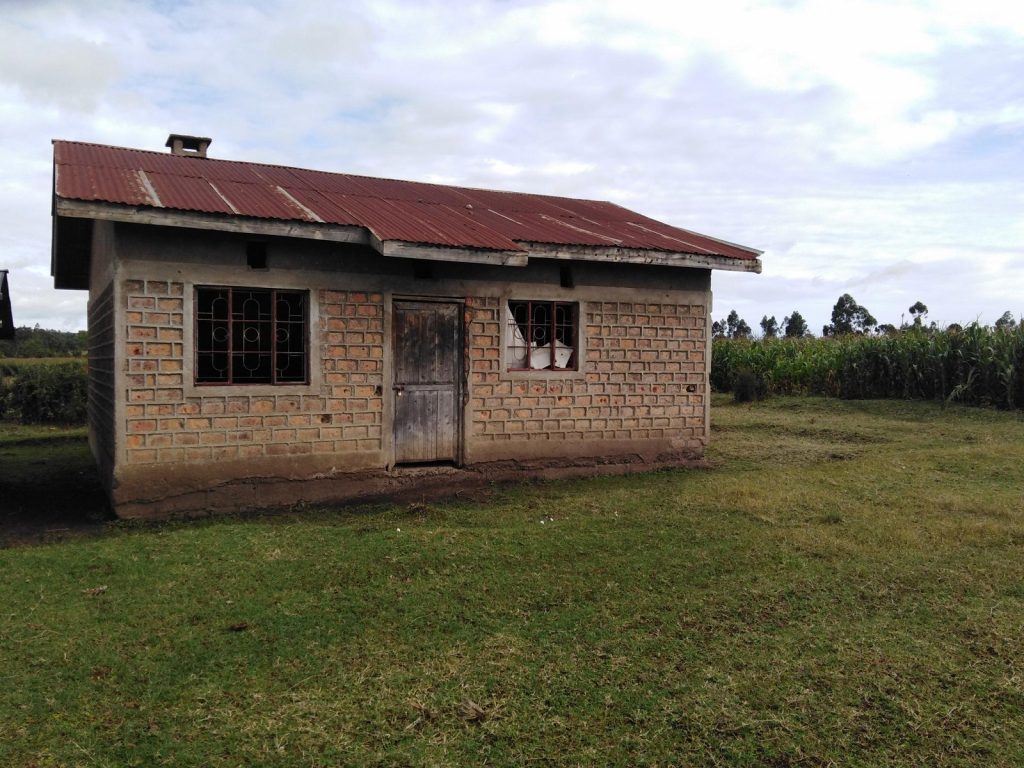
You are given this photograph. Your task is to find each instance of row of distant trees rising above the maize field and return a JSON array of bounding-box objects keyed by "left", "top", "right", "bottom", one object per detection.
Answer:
[{"left": 712, "top": 293, "right": 1018, "bottom": 339}]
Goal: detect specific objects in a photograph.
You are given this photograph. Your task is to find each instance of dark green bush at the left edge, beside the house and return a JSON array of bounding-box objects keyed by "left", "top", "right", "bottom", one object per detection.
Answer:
[{"left": 0, "top": 362, "right": 88, "bottom": 424}]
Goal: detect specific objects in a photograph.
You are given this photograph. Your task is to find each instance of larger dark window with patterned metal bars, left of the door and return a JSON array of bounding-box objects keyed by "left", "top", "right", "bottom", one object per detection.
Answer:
[{"left": 196, "top": 288, "right": 308, "bottom": 384}]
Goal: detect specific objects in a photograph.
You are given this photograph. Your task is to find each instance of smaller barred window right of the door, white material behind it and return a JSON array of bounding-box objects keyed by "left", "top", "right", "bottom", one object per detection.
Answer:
[{"left": 505, "top": 301, "right": 579, "bottom": 371}]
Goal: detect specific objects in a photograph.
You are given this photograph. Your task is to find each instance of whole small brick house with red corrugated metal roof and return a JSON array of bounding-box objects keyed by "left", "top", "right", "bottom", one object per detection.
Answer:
[{"left": 51, "top": 134, "right": 761, "bottom": 517}]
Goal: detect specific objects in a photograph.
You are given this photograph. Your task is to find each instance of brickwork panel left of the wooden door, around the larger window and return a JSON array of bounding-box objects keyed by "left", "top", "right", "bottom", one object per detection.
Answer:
[{"left": 122, "top": 280, "right": 384, "bottom": 465}]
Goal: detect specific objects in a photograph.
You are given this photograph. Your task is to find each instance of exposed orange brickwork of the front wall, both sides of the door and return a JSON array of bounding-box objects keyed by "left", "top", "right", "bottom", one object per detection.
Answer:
[{"left": 114, "top": 280, "right": 708, "bottom": 474}]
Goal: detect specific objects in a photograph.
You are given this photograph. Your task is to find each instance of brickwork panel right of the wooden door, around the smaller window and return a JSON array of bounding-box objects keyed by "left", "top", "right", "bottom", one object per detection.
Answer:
[{"left": 467, "top": 298, "right": 708, "bottom": 454}]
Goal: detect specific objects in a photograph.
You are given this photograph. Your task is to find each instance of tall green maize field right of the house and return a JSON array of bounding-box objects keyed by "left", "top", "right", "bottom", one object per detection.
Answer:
[{"left": 711, "top": 324, "right": 1024, "bottom": 409}]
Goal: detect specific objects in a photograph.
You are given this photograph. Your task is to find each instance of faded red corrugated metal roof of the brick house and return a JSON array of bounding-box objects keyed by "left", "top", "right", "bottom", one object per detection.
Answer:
[{"left": 53, "top": 140, "right": 761, "bottom": 261}]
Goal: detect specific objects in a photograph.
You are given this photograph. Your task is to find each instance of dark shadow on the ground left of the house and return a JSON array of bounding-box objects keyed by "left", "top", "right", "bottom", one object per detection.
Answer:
[{"left": 0, "top": 422, "right": 113, "bottom": 547}]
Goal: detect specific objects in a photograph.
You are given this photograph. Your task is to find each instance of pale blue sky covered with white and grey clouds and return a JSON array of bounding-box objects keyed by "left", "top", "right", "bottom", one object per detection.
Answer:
[{"left": 0, "top": 0, "right": 1024, "bottom": 333}]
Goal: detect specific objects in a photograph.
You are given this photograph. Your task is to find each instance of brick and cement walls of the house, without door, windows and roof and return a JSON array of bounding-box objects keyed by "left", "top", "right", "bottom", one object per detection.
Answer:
[{"left": 101, "top": 225, "right": 711, "bottom": 516}]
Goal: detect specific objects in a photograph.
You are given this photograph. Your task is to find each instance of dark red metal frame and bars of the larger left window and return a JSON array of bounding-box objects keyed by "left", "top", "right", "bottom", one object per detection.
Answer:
[{"left": 189, "top": 285, "right": 312, "bottom": 389}]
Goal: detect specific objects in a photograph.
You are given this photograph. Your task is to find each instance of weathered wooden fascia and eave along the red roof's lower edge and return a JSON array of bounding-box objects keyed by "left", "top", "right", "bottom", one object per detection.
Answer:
[{"left": 51, "top": 197, "right": 761, "bottom": 289}]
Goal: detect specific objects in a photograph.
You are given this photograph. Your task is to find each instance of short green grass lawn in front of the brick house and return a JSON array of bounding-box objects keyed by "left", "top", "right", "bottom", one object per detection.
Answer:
[{"left": 0, "top": 398, "right": 1024, "bottom": 766}]
